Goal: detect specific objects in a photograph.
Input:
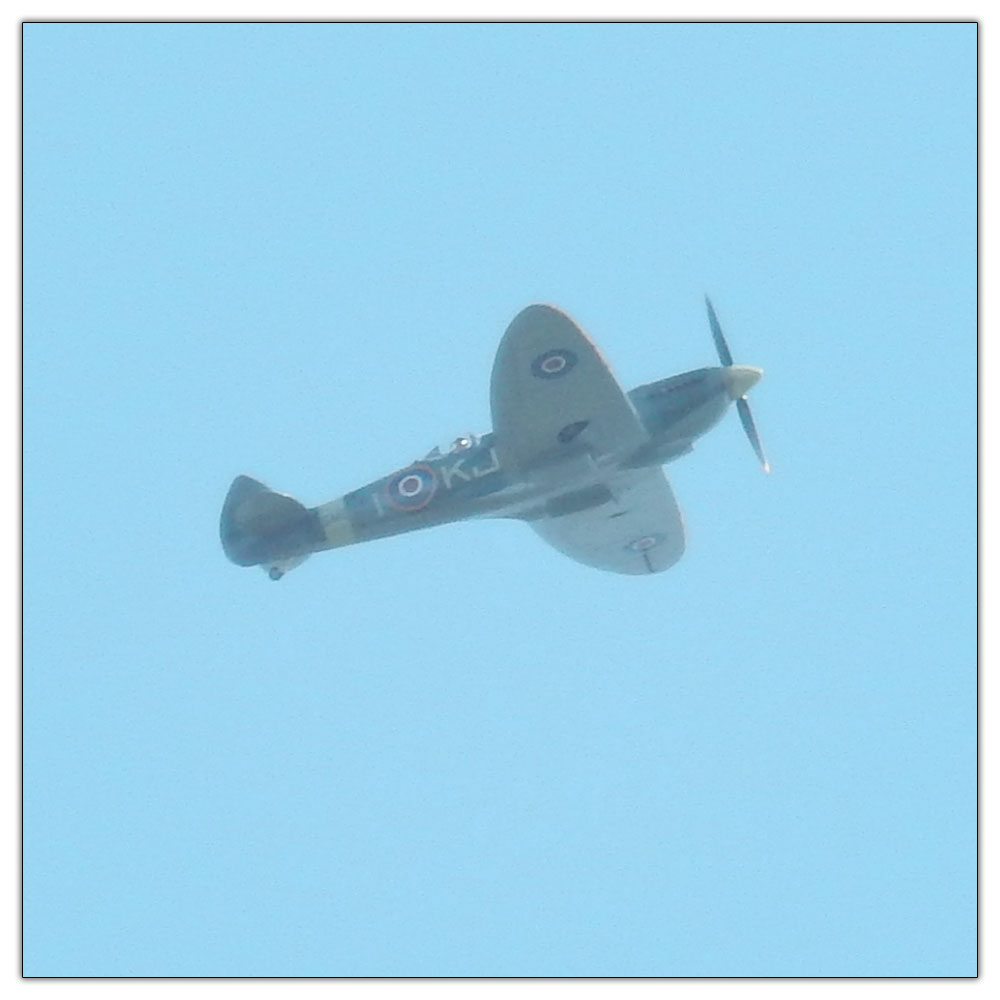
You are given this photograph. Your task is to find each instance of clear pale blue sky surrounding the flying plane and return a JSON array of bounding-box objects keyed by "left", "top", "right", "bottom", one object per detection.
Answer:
[{"left": 23, "top": 24, "right": 976, "bottom": 976}]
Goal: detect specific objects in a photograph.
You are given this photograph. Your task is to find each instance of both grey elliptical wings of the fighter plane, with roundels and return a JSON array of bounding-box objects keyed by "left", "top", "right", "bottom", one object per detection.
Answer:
[{"left": 490, "top": 305, "right": 684, "bottom": 574}]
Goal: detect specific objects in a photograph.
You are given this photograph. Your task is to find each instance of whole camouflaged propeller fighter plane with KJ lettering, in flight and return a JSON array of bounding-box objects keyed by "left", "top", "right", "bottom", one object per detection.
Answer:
[{"left": 220, "top": 295, "right": 770, "bottom": 580}]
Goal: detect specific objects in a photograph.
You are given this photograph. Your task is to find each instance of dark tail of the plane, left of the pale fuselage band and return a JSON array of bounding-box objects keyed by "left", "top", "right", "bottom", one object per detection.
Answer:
[{"left": 219, "top": 476, "right": 324, "bottom": 580}]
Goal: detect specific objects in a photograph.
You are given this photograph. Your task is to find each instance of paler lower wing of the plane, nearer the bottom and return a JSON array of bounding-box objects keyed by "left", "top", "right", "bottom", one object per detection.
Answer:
[{"left": 528, "top": 468, "right": 684, "bottom": 575}]
